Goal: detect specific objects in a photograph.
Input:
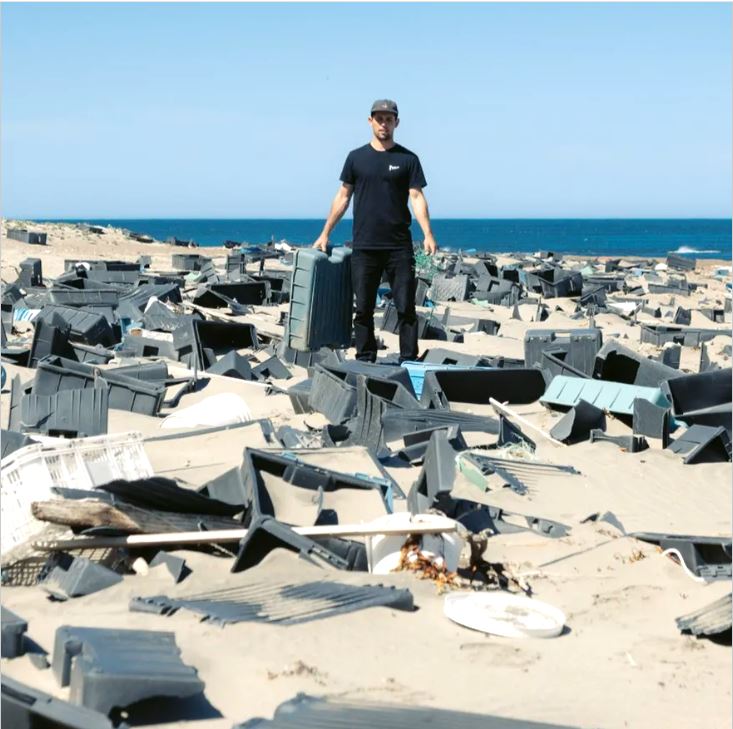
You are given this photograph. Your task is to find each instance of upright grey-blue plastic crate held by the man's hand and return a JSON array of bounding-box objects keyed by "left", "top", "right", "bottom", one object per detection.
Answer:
[{"left": 287, "top": 248, "right": 353, "bottom": 352}]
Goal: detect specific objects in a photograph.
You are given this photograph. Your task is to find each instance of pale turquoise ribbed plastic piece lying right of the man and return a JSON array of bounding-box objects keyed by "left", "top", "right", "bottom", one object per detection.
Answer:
[{"left": 540, "top": 375, "right": 669, "bottom": 415}]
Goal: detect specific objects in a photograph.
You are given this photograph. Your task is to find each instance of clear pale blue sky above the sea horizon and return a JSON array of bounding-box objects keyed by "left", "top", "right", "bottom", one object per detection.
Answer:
[{"left": 2, "top": 3, "right": 732, "bottom": 218}]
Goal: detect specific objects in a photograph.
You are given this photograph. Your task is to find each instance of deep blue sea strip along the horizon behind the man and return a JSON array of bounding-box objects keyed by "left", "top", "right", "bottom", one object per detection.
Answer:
[{"left": 43, "top": 218, "right": 731, "bottom": 260}]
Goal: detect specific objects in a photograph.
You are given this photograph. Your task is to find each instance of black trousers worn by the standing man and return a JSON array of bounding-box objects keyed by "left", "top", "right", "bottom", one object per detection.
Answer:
[{"left": 351, "top": 246, "right": 417, "bottom": 362}]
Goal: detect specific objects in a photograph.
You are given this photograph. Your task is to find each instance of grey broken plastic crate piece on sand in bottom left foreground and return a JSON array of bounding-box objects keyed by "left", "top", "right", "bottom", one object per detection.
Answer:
[{"left": 51, "top": 625, "right": 204, "bottom": 714}]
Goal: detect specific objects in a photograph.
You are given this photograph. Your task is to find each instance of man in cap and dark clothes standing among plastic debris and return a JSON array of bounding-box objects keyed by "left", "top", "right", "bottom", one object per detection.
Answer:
[{"left": 314, "top": 99, "right": 438, "bottom": 362}]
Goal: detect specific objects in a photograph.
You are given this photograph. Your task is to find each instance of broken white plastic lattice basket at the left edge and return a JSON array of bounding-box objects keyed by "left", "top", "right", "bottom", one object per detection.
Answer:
[{"left": 0, "top": 433, "right": 153, "bottom": 554}]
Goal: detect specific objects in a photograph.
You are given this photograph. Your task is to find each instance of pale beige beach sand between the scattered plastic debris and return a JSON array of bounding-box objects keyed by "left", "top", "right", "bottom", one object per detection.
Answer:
[{"left": 1, "top": 223, "right": 732, "bottom": 729}]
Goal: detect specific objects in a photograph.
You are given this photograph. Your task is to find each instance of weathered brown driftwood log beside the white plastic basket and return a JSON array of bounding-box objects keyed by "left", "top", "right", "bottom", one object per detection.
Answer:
[{"left": 31, "top": 499, "right": 239, "bottom": 534}]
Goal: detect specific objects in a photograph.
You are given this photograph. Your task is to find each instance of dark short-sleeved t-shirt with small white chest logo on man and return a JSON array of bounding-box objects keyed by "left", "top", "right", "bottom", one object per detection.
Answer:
[{"left": 341, "top": 144, "right": 428, "bottom": 249}]
